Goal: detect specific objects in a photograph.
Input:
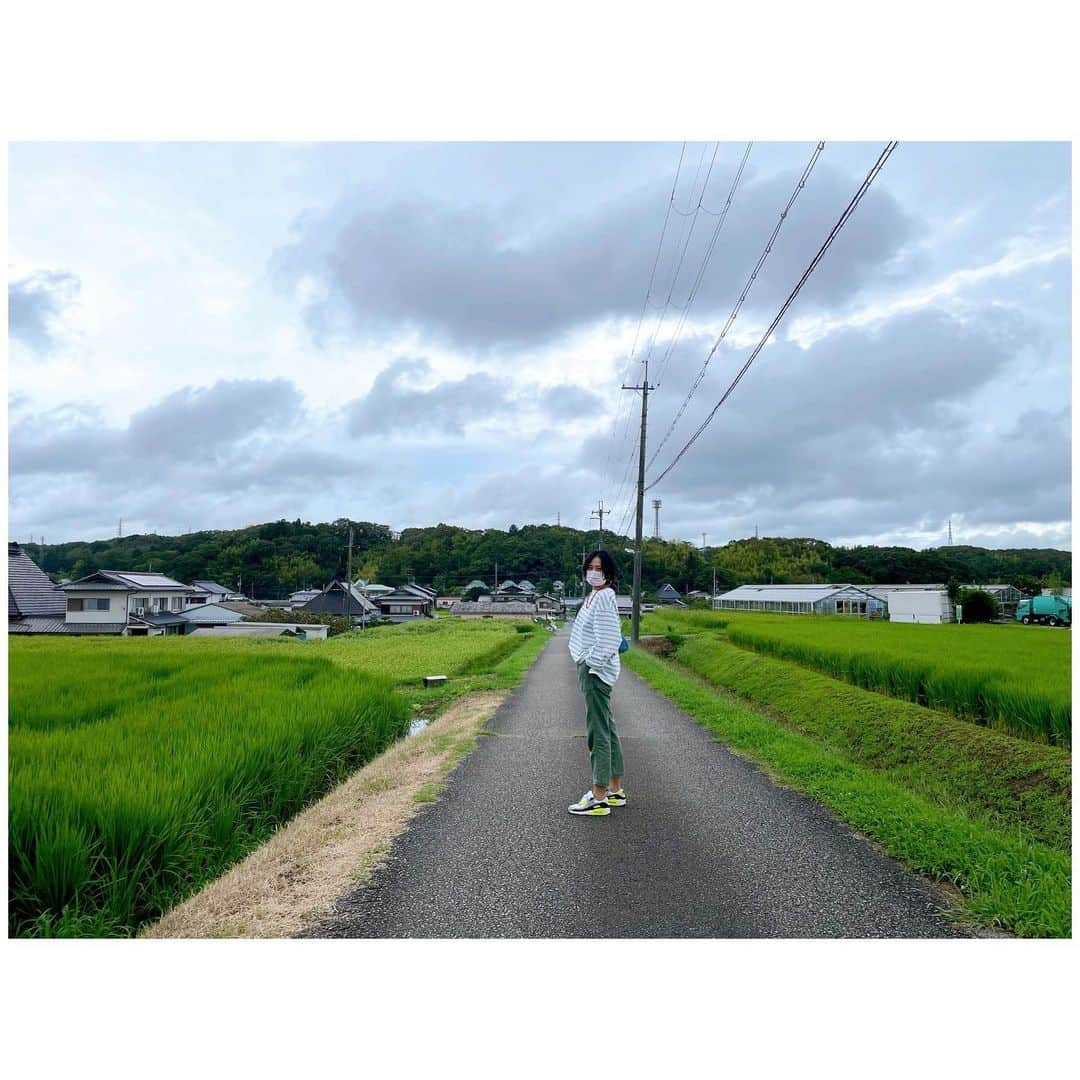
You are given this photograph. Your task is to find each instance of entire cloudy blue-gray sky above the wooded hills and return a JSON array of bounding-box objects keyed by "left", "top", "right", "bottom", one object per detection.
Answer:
[{"left": 9, "top": 139, "right": 1071, "bottom": 548}]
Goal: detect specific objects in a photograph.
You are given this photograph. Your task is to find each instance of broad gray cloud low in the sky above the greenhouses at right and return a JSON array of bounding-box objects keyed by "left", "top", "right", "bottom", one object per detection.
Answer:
[{"left": 579, "top": 308, "right": 1070, "bottom": 538}]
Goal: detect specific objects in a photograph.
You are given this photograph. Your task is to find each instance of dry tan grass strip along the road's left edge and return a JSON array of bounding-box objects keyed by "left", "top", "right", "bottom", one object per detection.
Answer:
[{"left": 138, "top": 691, "right": 507, "bottom": 937}]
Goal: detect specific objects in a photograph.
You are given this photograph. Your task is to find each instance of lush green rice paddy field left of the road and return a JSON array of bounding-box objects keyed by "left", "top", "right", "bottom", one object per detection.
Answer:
[{"left": 9, "top": 620, "right": 546, "bottom": 936}]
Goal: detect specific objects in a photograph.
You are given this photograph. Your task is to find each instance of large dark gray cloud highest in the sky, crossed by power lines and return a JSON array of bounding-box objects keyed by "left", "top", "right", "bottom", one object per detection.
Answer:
[{"left": 273, "top": 154, "right": 916, "bottom": 349}]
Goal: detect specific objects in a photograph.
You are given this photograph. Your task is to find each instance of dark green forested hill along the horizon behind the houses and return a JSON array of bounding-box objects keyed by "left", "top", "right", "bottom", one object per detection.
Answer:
[{"left": 24, "top": 519, "right": 1072, "bottom": 598}]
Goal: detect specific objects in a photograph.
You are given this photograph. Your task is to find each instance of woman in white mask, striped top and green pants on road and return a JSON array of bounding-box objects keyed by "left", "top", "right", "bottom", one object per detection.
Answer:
[{"left": 567, "top": 551, "right": 626, "bottom": 816}]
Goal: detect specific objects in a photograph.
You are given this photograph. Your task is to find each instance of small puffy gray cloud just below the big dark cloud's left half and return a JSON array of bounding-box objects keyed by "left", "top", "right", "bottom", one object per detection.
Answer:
[{"left": 346, "top": 357, "right": 511, "bottom": 438}]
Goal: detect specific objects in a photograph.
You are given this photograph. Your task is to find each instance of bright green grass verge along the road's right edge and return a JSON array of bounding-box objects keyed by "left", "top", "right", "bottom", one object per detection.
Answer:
[{"left": 623, "top": 649, "right": 1071, "bottom": 937}]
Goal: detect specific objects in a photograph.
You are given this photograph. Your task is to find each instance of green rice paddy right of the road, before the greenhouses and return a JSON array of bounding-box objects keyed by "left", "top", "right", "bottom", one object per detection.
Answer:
[{"left": 642, "top": 610, "right": 1072, "bottom": 746}]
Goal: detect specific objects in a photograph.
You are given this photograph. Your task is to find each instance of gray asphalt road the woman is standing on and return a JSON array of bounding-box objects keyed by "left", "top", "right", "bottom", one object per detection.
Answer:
[{"left": 305, "top": 629, "right": 968, "bottom": 937}]
